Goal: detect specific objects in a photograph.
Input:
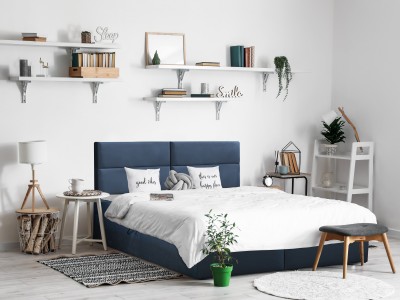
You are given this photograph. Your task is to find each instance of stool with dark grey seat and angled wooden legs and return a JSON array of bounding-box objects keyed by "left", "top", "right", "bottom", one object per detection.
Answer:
[{"left": 313, "top": 223, "right": 396, "bottom": 279}]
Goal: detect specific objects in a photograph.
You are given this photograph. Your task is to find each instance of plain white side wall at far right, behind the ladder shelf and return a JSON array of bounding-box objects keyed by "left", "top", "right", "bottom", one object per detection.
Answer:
[{"left": 332, "top": 0, "right": 400, "bottom": 237}]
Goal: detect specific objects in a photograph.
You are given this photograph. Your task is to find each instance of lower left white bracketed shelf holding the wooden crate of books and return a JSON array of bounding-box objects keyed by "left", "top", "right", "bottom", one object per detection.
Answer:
[{"left": 10, "top": 76, "right": 121, "bottom": 103}]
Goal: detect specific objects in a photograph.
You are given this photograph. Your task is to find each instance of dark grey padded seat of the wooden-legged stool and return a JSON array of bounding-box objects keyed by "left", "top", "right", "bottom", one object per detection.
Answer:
[{"left": 319, "top": 223, "right": 388, "bottom": 236}]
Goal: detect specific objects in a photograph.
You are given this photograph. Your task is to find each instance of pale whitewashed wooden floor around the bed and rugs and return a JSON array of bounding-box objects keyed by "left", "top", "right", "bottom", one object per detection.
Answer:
[{"left": 0, "top": 239, "right": 400, "bottom": 300}]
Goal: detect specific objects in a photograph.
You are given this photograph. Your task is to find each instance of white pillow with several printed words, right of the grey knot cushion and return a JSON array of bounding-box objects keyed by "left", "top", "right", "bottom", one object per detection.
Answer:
[{"left": 187, "top": 166, "right": 222, "bottom": 190}]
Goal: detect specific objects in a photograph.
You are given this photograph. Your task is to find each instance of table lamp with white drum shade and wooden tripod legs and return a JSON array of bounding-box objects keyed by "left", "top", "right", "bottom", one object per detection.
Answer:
[{"left": 18, "top": 141, "right": 50, "bottom": 212}]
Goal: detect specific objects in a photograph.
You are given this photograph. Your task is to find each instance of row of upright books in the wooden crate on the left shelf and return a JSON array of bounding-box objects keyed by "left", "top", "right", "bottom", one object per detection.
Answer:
[{"left": 72, "top": 52, "right": 115, "bottom": 68}]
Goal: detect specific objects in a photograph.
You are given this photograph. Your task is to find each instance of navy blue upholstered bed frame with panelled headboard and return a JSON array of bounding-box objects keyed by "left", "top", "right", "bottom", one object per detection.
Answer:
[{"left": 93, "top": 142, "right": 368, "bottom": 279}]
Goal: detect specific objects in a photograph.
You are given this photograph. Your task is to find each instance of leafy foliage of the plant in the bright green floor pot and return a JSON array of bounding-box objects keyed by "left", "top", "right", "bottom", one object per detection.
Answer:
[{"left": 202, "top": 210, "right": 238, "bottom": 268}]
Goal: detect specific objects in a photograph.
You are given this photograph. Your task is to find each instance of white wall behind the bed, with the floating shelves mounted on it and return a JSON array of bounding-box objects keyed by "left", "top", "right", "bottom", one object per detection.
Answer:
[{"left": 0, "top": 0, "right": 333, "bottom": 248}]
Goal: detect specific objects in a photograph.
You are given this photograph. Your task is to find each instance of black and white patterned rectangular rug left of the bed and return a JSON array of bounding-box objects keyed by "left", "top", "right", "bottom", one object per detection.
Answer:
[{"left": 38, "top": 253, "right": 182, "bottom": 288}]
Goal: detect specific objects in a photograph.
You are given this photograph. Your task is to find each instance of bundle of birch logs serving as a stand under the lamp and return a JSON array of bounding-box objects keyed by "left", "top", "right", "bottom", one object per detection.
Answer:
[{"left": 17, "top": 213, "right": 60, "bottom": 254}]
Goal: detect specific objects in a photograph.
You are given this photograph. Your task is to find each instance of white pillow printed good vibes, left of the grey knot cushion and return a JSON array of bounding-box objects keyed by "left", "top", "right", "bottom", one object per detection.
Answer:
[{"left": 125, "top": 168, "right": 161, "bottom": 193}]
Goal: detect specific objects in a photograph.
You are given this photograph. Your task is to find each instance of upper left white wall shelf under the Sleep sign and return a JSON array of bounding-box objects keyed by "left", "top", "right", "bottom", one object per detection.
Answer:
[{"left": 0, "top": 40, "right": 120, "bottom": 49}]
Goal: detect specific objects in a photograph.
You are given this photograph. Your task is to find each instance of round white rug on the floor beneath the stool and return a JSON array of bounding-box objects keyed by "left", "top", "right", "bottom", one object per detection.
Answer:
[{"left": 254, "top": 271, "right": 394, "bottom": 300}]
